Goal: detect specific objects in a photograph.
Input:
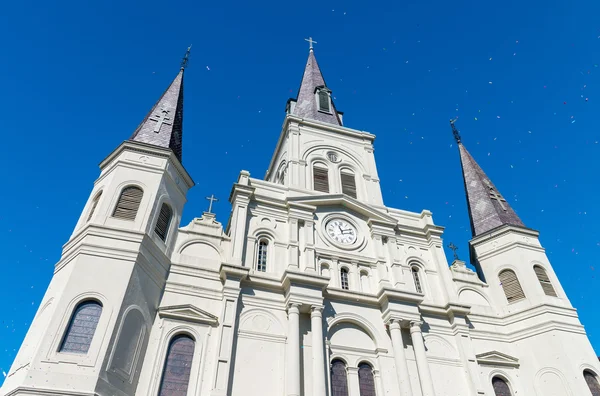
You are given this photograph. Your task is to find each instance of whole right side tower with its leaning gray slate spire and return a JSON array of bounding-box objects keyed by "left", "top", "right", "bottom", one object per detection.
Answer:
[{"left": 451, "top": 122, "right": 600, "bottom": 395}]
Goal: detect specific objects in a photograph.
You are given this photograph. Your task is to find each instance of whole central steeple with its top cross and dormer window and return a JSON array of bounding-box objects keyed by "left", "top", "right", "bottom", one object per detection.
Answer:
[{"left": 288, "top": 43, "right": 342, "bottom": 125}]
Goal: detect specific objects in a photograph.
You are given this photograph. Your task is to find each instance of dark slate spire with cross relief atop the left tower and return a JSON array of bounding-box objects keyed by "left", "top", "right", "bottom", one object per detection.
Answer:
[{"left": 129, "top": 67, "right": 184, "bottom": 161}]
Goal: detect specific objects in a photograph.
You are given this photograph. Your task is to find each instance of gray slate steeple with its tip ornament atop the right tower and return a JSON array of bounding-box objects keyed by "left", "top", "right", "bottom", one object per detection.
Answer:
[{"left": 450, "top": 121, "right": 525, "bottom": 237}]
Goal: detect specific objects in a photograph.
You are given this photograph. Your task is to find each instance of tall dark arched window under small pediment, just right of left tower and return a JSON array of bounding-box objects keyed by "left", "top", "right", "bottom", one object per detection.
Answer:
[{"left": 158, "top": 334, "right": 195, "bottom": 396}]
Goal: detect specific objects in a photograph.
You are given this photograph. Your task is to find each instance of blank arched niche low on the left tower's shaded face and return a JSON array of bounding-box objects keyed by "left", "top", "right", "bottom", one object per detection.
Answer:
[{"left": 111, "top": 309, "right": 146, "bottom": 376}]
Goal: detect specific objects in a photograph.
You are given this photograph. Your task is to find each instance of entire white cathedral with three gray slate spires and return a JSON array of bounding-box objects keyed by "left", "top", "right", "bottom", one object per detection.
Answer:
[{"left": 0, "top": 43, "right": 600, "bottom": 396}]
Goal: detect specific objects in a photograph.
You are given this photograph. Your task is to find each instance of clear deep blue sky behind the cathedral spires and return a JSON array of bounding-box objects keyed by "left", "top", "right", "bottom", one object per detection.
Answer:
[{"left": 0, "top": 0, "right": 600, "bottom": 383}]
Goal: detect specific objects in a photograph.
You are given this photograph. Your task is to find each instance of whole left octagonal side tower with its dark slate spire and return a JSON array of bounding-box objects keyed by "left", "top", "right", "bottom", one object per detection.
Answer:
[{"left": 0, "top": 57, "right": 194, "bottom": 395}]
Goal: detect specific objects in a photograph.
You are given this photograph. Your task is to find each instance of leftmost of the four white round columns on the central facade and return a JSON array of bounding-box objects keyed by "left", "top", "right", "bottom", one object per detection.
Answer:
[{"left": 285, "top": 304, "right": 300, "bottom": 396}]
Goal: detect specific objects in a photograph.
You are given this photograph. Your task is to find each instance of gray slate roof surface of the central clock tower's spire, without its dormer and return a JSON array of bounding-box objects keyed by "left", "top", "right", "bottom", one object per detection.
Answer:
[{"left": 292, "top": 48, "right": 342, "bottom": 125}]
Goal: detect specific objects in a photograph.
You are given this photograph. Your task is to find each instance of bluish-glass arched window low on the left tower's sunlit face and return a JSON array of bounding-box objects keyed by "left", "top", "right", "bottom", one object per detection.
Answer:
[{"left": 58, "top": 300, "right": 102, "bottom": 355}]
